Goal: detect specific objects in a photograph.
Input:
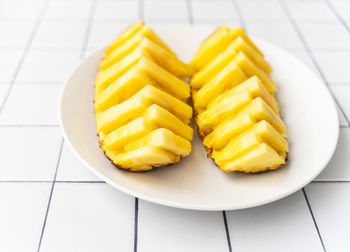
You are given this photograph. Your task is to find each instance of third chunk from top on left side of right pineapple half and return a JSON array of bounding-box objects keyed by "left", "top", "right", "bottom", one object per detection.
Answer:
[{"left": 193, "top": 61, "right": 246, "bottom": 108}]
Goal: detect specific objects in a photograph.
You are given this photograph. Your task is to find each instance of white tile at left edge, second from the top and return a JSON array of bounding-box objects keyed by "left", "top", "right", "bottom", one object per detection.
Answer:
[{"left": 0, "top": 20, "right": 34, "bottom": 49}]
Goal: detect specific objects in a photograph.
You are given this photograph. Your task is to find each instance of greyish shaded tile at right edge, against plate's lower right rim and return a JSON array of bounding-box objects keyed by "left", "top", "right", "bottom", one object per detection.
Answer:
[{"left": 315, "top": 128, "right": 350, "bottom": 181}]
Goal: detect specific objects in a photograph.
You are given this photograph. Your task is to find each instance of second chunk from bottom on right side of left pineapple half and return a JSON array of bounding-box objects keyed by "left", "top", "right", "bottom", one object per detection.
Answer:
[{"left": 145, "top": 104, "right": 193, "bottom": 140}]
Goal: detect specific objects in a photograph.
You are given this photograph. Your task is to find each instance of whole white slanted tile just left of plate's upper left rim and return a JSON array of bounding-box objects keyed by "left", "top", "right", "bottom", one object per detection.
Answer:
[{"left": 17, "top": 51, "right": 80, "bottom": 83}]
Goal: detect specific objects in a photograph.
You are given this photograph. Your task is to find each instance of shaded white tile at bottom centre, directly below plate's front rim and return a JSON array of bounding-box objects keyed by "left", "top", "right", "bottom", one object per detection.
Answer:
[{"left": 138, "top": 200, "right": 228, "bottom": 252}]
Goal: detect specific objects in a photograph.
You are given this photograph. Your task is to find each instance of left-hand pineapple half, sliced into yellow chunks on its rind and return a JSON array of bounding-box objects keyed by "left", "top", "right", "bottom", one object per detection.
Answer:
[{"left": 94, "top": 22, "right": 193, "bottom": 171}]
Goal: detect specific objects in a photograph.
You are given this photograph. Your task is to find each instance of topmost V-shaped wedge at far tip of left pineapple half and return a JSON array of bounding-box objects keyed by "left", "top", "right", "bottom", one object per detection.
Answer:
[{"left": 105, "top": 22, "right": 176, "bottom": 57}]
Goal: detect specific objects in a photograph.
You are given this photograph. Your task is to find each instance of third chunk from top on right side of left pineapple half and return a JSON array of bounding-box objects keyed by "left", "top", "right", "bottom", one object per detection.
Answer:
[{"left": 137, "top": 57, "right": 190, "bottom": 100}]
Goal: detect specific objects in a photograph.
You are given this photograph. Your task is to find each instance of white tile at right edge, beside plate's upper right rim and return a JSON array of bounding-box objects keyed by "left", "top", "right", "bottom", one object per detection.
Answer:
[{"left": 313, "top": 51, "right": 350, "bottom": 84}]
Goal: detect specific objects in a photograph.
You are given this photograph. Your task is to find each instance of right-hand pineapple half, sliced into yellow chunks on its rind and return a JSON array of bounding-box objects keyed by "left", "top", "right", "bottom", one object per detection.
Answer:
[{"left": 190, "top": 25, "right": 289, "bottom": 173}]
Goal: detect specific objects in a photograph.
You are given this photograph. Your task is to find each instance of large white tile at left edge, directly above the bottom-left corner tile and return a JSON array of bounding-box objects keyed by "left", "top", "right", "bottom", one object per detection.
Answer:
[{"left": 0, "top": 127, "right": 62, "bottom": 181}]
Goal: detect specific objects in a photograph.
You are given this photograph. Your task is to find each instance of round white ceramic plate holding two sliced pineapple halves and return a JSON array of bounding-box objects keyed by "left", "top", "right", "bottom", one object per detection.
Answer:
[{"left": 60, "top": 27, "right": 339, "bottom": 210}]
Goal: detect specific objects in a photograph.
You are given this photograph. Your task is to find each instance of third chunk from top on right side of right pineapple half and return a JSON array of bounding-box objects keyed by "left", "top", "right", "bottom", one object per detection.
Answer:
[{"left": 235, "top": 52, "right": 277, "bottom": 93}]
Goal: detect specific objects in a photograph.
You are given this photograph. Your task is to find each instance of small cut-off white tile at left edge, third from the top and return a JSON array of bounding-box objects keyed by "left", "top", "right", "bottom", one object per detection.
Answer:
[{"left": 0, "top": 50, "right": 23, "bottom": 82}]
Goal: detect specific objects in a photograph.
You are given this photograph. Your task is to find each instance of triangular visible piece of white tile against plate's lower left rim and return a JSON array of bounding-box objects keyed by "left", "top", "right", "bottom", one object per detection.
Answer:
[{"left": 56, "top": 143, "right": 101, "bottom": 181}]
